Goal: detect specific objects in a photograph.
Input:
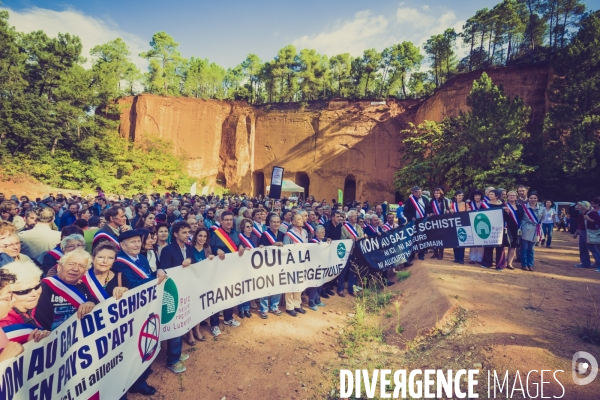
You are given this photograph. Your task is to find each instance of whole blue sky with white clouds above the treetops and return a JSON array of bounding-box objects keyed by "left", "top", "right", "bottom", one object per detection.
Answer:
[{"left": 0, "top": 0, "right": 600, "bottom": 70}]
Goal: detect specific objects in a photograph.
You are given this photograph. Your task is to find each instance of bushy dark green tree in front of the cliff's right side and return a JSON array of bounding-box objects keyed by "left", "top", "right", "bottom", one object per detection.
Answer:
[{"left": 396, "top": 73, "right": 534, "bottom": 192}]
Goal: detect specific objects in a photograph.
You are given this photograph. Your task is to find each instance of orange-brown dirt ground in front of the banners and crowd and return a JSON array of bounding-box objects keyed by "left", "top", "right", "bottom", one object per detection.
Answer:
[{"left": 129, "top": 232, "right": 600, "bottom": 400}]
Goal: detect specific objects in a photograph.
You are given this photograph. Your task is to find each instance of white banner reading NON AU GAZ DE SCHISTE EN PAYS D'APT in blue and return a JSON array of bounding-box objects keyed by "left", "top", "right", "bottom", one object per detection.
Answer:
[{"left": 0, "top": 281, "right": 163, "bottom": 400}]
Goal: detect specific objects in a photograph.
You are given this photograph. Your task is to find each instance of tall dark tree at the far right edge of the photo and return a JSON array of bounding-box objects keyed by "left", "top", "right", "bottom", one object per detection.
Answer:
[{"left": 539, "top": 11, "right": 600, "bottom": 198}]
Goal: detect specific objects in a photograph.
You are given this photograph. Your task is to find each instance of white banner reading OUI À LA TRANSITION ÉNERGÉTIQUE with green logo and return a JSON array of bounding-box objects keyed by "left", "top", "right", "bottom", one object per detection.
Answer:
[{"left": 160, "top": 240, "right": 352, "bottom": 340}]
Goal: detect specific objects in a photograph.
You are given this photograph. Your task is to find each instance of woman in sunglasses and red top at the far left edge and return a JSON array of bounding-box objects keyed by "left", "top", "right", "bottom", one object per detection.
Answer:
[{"left": 0, "top": 261, "right": 50, "bottom": 344}]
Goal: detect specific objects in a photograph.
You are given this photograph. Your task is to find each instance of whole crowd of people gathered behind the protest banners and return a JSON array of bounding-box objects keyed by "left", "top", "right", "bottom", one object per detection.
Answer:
[{"left": 0, "top": 186, "right": 600, "bottom": 395}]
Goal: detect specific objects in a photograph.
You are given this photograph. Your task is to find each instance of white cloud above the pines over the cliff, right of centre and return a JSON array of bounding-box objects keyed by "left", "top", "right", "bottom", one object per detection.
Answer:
[{"left": 292, "top": 3, "right": 464, "bottom": 56}]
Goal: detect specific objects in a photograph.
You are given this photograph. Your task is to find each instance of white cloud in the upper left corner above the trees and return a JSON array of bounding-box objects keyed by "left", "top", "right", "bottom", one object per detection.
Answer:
[{"left": 1, "top": 7, "right": 149, "bottom": 72}]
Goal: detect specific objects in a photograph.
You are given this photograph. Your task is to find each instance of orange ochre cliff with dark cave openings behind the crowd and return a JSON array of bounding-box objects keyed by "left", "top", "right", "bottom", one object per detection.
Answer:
[{"left": 120, "top": 67, "right": 549, "bottom": 202}]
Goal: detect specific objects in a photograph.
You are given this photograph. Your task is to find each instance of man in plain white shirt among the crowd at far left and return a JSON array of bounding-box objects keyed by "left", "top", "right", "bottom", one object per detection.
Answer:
[{"left": 19, "top": 208, "right": 60, "bottom": 265}]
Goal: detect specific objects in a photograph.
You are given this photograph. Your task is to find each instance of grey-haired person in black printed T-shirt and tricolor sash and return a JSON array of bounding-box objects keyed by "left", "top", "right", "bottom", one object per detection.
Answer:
[{"left": 36, "top": 249, "right": 98, "bottom": 331}]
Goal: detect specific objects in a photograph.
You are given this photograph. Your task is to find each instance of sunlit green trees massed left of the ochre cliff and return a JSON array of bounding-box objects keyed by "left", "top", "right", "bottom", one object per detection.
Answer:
[{"left": 0, "top": 11, "right": 191, "bottom": 193}]
